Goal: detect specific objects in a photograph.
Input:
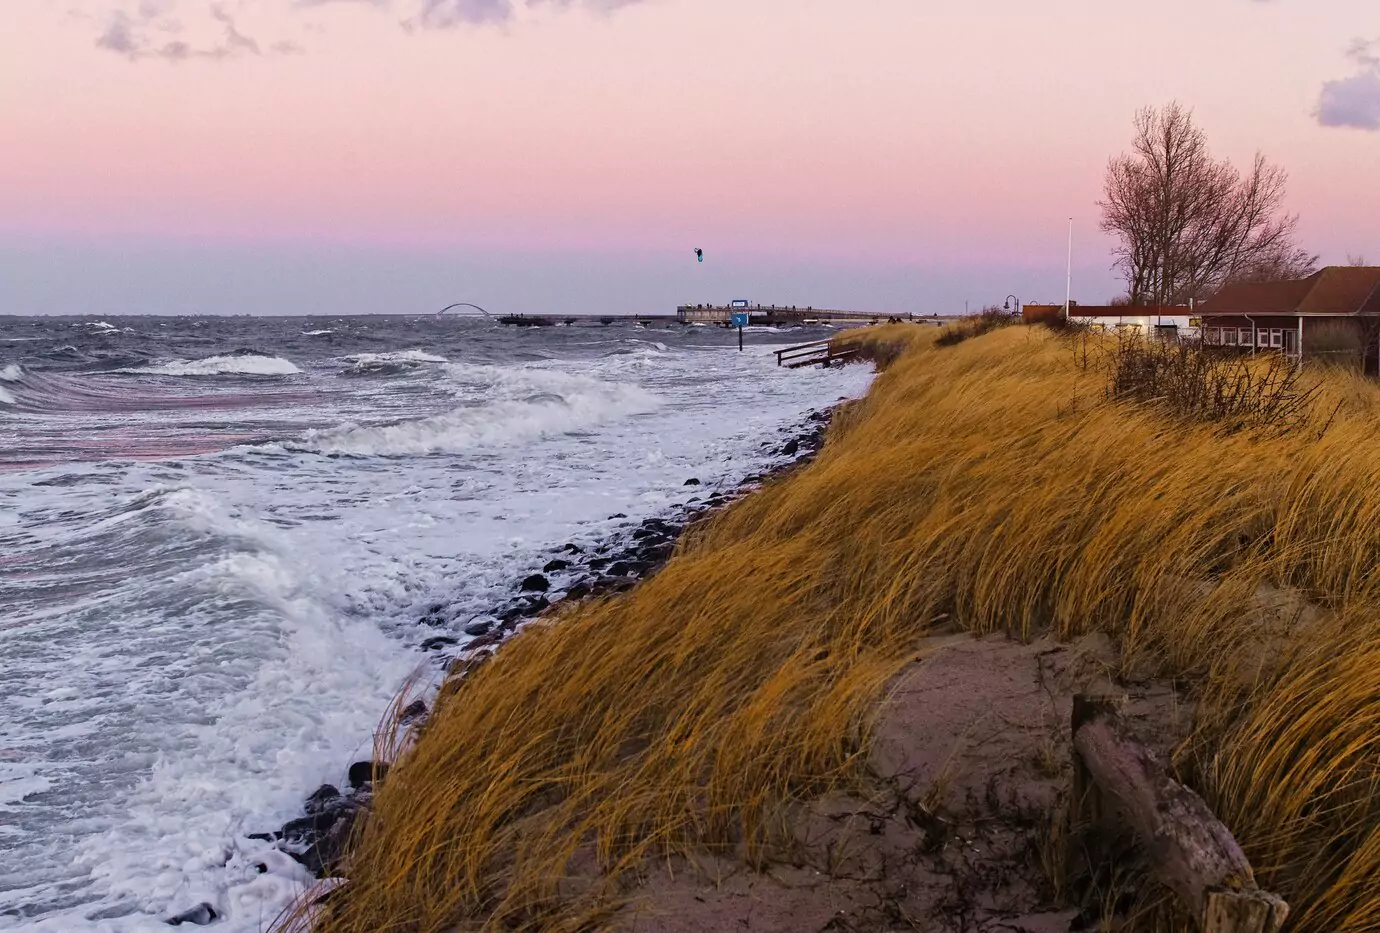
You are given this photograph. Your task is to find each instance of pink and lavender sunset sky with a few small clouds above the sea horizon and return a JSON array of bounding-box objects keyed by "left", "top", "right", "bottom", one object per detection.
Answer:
[{"left": 0, "top": 0, "right": 1380, "bottom": 315}]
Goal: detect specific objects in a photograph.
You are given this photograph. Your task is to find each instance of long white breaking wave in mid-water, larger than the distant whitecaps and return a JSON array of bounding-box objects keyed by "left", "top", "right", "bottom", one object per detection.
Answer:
[{"left": 301, "top": 364, "right": 661, "bottom": 457}]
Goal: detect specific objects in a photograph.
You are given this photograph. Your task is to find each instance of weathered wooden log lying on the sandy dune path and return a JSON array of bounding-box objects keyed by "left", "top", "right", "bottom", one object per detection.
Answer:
[{"left": 1072, "top": 696, "right": 1289, "bottom": 933}]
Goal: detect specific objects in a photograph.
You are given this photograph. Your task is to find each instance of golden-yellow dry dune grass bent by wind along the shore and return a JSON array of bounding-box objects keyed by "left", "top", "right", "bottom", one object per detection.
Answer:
[{"left": 297, "top": 326, "right": 1380, "bottom": 933}]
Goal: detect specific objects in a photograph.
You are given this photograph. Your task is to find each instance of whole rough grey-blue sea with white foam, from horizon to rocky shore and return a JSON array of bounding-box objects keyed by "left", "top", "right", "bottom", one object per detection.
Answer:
[{"left": 0, "top": 315, "right": 872, "bottom": 933}]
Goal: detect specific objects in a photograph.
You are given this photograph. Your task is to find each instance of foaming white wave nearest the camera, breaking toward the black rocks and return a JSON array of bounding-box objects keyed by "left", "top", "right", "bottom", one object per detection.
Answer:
[{"left": 0, "top": 487, "right": 418, "bottom": 933}]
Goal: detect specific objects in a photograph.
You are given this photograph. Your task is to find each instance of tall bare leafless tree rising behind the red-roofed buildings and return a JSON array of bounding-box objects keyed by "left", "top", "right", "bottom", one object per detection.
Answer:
[{"left": 1098, "top": 104, "right": 1317, "bottom": 305}]
